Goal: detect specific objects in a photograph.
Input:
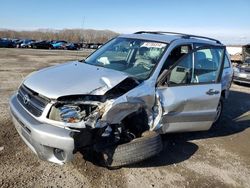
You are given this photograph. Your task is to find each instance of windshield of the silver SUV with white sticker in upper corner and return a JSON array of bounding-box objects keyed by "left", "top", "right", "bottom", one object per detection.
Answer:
[{"left": 85, "top": 38, "right": 167, "bottom": 80}]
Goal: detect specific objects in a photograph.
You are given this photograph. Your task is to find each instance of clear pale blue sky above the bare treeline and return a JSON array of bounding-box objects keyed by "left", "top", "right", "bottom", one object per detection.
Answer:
[{"left": 0, "top": 0, "right": 250, "bottom": 44}]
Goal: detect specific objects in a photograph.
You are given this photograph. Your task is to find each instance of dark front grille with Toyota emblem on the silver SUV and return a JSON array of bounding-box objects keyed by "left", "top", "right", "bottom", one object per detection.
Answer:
[{"left": 17, "top": 85, "right": 49, "bottom": 117}]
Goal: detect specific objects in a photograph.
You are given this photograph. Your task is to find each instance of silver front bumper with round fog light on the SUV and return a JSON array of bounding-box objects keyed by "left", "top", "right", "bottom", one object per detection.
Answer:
[{"left": 10, "top": 94, "right": 74, "bottom": 164}]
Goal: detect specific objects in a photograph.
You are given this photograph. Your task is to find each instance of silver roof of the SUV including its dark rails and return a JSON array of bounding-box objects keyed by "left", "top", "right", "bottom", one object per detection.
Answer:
[{"left": 120, "top": 31, "right": 221, "bottom": 45}]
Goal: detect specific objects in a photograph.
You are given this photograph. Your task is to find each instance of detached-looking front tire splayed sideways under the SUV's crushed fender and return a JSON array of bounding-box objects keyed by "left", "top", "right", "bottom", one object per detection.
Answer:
[{"left": 98, "top": 131, "right": 162, "bottom": 169}]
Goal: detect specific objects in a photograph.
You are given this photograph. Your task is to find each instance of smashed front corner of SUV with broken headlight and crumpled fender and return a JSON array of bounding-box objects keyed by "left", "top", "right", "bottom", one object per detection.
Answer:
[{"left": 47, "top": 78, "right": 152, "bottom": 155}]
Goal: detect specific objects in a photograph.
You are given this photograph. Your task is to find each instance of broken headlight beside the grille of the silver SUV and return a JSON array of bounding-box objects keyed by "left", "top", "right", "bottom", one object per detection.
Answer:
[{"left": 48, "top": 104, "right": 97, "bottom": 123}]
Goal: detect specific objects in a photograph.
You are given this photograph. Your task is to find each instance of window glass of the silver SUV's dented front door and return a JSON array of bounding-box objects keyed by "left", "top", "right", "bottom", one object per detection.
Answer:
[{"left": 168, "top": 47, "right": 224, "bottom": 86}]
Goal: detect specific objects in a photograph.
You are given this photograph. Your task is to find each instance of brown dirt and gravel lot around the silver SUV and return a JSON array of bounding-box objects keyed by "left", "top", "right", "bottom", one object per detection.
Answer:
[{"left": 0, "top": 49, "right": 250, "bottom": 187}]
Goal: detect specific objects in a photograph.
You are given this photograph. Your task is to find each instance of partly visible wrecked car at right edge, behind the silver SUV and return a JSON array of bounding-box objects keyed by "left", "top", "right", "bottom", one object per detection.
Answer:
[{"left": 233, "top": 44, "right": 250, "bottom": 84}]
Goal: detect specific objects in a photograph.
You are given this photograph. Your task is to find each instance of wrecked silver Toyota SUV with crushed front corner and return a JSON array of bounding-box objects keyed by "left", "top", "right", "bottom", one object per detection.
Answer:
[{"left": 10, "top": 31, "right": 233, "bottom": 167}]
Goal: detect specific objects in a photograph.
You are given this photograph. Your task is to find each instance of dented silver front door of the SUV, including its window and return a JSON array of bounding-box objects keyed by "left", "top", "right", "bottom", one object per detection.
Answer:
[{"left": 156, "top": 46, "right": 225, "bottom": 133}]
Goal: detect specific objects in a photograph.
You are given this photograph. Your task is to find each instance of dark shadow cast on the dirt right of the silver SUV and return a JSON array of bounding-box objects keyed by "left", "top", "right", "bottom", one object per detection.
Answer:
[{"left": 128, "top": 91, "right": 250, "bottom": 168}]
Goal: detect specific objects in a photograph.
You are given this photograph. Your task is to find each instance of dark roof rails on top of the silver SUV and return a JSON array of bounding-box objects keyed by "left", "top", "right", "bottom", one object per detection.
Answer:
[{"left": 134, "top": 31, "right": 221, "bottom": 44}]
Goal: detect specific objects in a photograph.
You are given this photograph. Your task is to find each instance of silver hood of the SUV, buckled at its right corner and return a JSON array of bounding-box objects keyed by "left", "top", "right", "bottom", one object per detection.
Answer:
[{"left": 23, "top": 62, "right": 128, "bottom": 99}]
